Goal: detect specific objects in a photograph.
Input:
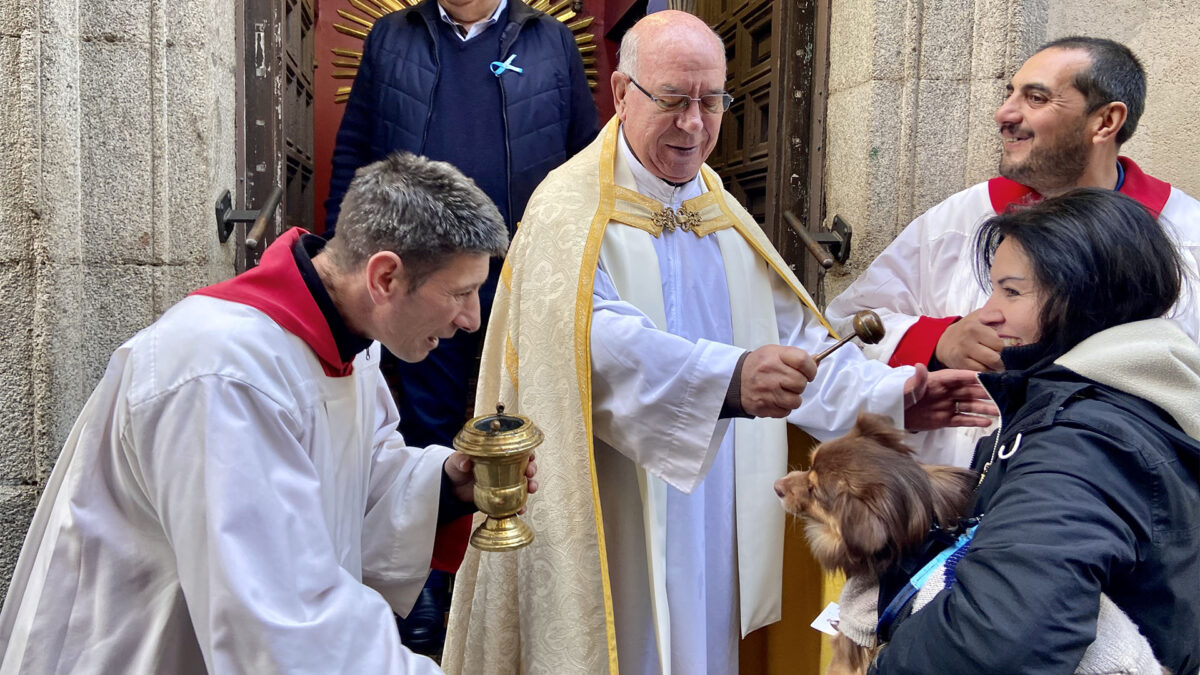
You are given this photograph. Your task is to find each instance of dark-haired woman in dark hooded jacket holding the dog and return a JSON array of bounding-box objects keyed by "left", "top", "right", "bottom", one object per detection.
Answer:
[{"left": 872, "top": 190, "right": 1200, "bottom": 675}]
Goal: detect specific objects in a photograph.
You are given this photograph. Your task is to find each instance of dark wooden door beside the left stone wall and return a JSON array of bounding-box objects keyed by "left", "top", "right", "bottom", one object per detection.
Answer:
[{"left": 236, "top": 0, "right": 314, "bottom": 273}]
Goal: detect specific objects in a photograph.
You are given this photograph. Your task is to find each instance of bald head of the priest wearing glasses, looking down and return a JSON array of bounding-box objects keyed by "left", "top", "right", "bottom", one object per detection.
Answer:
[{"left": 612, "top": 10, "right": 732, "bottom": 183}]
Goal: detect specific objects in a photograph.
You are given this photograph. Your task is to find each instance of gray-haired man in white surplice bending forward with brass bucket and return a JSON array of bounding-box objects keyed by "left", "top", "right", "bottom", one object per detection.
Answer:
[{"left": 0, "top": 155, "right": 536, "bottom": 673}]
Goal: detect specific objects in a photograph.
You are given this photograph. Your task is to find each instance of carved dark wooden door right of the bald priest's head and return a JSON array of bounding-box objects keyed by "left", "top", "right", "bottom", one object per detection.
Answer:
[{"left": 696, "top": 0, "right": 824, "bottom": 303}]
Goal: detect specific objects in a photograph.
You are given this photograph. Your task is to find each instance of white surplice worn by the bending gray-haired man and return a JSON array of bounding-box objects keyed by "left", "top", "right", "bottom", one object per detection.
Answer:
[{"left": 0, "top": 295, "right": 450, "bottom": 675}]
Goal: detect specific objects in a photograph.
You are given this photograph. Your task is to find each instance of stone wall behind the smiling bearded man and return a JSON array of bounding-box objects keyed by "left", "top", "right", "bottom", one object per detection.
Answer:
[{"left": 826, "top": 0, "right": 1200, "bottom": 298}]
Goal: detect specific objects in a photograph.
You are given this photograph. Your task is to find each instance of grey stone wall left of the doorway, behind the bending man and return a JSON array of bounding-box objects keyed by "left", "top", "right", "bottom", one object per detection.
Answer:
[{"left": 0, "top": 0, "right": 238, "bottom": 595}]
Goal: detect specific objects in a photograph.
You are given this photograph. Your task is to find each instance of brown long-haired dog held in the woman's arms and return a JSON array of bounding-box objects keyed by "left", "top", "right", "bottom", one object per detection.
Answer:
[{"left": 775, "top": 413, "right": 977, "bottom": 674}]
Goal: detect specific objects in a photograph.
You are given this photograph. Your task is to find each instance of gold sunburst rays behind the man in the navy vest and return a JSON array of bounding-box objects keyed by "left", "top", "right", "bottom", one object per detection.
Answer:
[{"left": 330, "top": 0, "right": 596, "bottom": 103}]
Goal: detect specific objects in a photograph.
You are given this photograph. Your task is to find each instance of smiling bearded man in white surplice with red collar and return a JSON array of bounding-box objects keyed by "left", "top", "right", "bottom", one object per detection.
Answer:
[{"left": 828, "top": 37, "right": 1200, "bottom": 466}]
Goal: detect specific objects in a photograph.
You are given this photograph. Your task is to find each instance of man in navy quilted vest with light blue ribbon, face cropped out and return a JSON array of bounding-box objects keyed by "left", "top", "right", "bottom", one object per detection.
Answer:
[{"left": 325, "top": 0, "right": 596, "bottom": 653}]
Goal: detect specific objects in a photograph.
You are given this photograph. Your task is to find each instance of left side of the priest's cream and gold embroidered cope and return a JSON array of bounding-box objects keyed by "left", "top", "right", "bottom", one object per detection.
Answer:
[{"left": 442, "top": 124, "right": 618, "bottom": 675}]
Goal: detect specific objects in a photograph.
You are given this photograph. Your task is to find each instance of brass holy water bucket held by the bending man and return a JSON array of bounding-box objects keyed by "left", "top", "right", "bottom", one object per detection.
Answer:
[{"left": 454, "top": 405, "right": 542, "bottom": 551}]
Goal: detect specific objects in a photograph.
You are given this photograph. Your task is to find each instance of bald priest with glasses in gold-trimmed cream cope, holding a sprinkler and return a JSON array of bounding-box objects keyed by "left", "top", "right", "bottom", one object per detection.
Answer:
[{"left": 443, "top": 11, "right": 989, "bottom": 675}]
